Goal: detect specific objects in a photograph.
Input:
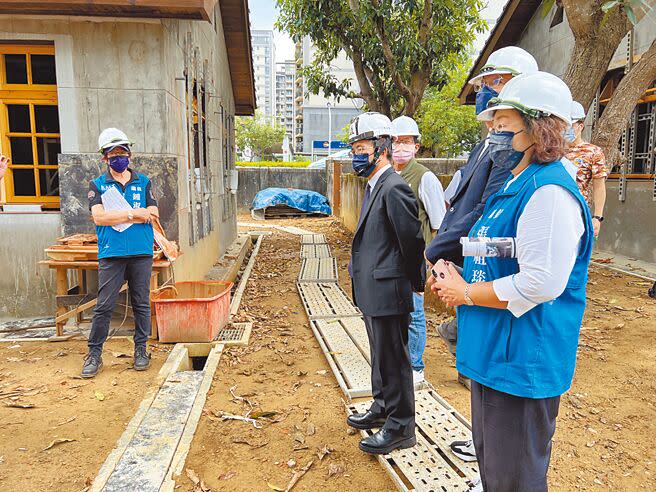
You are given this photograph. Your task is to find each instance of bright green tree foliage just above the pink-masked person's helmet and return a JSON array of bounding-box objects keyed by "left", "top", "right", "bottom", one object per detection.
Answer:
[{"left": 415, "top": 64, "right": 481, "bottom": 157}]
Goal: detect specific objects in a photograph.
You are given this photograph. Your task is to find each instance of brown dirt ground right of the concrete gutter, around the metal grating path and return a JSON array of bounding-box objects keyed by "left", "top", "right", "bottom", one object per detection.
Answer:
[{"left": 178, "top": 217, "right": 656, "bottom": 491}]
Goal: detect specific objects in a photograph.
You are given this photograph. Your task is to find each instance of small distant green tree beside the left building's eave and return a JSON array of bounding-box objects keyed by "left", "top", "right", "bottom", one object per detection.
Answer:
[{"left": 235, "top": 111, "right": 285, "bottom": 159}]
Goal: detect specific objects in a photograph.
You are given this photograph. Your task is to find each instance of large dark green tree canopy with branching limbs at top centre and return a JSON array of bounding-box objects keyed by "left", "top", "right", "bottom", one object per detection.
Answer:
[{"left": 276, "top": 0, "right": 485, "bottom": 117}]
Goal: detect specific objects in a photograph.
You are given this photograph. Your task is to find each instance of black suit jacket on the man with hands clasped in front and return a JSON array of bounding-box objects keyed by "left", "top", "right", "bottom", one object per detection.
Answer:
[{"left": 351, "top": 169, "right": 425, "bottom": 316}]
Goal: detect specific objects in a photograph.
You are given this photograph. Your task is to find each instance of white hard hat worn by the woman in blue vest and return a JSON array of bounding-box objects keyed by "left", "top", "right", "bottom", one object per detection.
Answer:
[{"left": 478, "top": 72, "right": 572, "bottom": 126}]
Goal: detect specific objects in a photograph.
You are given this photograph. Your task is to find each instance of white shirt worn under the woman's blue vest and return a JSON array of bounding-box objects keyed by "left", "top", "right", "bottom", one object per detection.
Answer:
[{"left": 492, "top": 171, "right": 585, "bottom": 318}]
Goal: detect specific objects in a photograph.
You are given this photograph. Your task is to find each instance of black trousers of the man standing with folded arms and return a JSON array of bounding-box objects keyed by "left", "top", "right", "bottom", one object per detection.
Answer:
[{"left": 88, "top": 256, "right": 153, "bottom": 355}]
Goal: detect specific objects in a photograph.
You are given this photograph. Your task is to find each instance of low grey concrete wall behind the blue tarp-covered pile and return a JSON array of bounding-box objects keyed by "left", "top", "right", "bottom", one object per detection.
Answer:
[{"left": 237, "top": 167, "right": 327, "bottom": 211}]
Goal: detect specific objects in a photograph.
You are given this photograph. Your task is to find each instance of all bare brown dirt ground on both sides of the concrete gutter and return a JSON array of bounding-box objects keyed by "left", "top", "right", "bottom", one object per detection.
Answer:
[{"left": 0, "top": 217, "right": 656, "bottom": 492}]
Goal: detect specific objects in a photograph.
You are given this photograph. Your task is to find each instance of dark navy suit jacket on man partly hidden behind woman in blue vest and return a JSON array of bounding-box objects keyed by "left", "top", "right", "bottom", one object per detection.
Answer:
[{"left": 426, "top": 140, "right": 510, "bottom": 266}]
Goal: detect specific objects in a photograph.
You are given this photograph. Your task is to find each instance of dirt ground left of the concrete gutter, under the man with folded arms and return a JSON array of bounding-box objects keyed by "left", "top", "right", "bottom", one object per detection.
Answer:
[{"left": 0, "top": 338, "right": 170, "bottom": 492}]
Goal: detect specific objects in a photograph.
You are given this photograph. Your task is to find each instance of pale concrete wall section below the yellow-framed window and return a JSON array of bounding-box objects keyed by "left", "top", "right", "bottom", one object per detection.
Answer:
[{"left": 0, "top": 212, "right": 61, "bottom": 320}]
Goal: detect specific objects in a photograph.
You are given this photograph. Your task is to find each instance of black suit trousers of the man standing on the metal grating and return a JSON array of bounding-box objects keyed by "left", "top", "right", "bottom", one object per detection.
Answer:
[{"left": 364, "top": 314, "right": 415, "bottom": 436}]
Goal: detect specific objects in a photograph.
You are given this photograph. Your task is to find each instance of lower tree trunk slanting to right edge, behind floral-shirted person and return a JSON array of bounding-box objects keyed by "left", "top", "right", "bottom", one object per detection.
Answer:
[{"left": 592, "top": 41, "right": 656, "bottom": 168}]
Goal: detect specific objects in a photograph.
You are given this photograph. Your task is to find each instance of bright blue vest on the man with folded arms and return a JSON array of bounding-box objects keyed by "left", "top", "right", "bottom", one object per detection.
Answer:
[{"left": 93, "top": 171, "right": 154, "bottom": 258}]
